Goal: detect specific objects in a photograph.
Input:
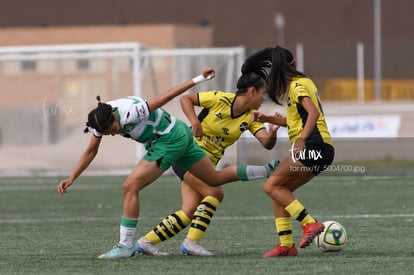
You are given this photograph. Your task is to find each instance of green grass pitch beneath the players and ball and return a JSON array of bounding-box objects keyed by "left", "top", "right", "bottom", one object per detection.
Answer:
[{"left": 0, "top": 176, "right": 414, "bottom": 274}]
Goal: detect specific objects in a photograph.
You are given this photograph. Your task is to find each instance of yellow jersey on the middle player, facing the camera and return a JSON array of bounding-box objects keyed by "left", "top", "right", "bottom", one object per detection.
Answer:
[{"left": 195, "top": 91, "right": 265, "bottom": 164}]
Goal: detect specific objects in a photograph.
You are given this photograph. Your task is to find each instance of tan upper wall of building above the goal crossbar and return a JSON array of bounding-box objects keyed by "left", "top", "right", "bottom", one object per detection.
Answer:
[{"left": 0, "top": 24, "right": 213, "bottom": 48}]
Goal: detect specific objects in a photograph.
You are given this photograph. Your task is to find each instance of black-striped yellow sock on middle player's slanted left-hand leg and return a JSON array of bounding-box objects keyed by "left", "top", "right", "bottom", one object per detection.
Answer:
[{"left": 145, "top": 210, "right": 191, "bottom": 244}]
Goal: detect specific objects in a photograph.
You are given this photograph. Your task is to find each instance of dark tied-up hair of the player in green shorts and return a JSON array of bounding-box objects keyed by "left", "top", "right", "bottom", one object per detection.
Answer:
[{"left": 83, "top": 95, "right": 115, "bottom": 133}]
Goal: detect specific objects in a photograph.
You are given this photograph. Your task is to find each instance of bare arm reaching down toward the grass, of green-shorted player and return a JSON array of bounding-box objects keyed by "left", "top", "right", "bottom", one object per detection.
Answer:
[{"left": 57, "top": 135, "right": 102, "bottom": 195}]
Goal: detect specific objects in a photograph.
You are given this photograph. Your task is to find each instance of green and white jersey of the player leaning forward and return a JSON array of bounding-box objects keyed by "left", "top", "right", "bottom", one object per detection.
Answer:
[{"left": 94, "top": 96, "right": 176, "bottom": 145}]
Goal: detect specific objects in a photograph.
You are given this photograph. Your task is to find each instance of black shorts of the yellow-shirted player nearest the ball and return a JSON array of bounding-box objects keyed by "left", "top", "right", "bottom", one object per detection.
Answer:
[{"left": 297, "top": 143, "right": 335, "bottom": 175}]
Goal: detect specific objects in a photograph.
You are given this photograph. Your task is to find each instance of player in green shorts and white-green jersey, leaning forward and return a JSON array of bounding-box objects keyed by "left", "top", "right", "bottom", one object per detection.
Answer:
[{"left": 57, "top": 68, "right": 278, "bottom": 259}]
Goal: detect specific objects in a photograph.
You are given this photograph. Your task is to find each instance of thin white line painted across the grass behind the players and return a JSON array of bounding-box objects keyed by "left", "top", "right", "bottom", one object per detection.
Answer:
[{"left": 0, "top": 213, "right": 414, "bottom": 224}]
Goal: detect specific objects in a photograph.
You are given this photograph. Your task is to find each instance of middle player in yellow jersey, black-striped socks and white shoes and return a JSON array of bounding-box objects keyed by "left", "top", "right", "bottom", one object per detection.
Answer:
[{"left": 135, "top": 51, "right": 278, "bottom": 256}]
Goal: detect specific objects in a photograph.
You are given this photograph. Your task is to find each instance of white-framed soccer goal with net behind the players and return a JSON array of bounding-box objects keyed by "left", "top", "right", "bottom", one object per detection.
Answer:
[{"left": 0, "top": 43, "right": 245, "bottom": 176}]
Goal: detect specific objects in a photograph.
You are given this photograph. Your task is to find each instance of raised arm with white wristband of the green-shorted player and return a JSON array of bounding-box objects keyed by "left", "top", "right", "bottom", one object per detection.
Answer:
[{"left": 148, "top": 68, "right": 215, "bottom": 111}]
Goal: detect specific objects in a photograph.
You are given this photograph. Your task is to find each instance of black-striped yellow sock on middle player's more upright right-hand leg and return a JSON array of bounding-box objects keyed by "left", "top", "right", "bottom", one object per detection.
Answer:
[{"left": 187, "top": 196, "right": 220, "bottom": 241}]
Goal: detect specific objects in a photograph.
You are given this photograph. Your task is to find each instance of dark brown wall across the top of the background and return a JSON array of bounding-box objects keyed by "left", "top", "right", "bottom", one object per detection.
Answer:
[{"left": 0, "top": 0, "right": 414, "bottom": 79}]
